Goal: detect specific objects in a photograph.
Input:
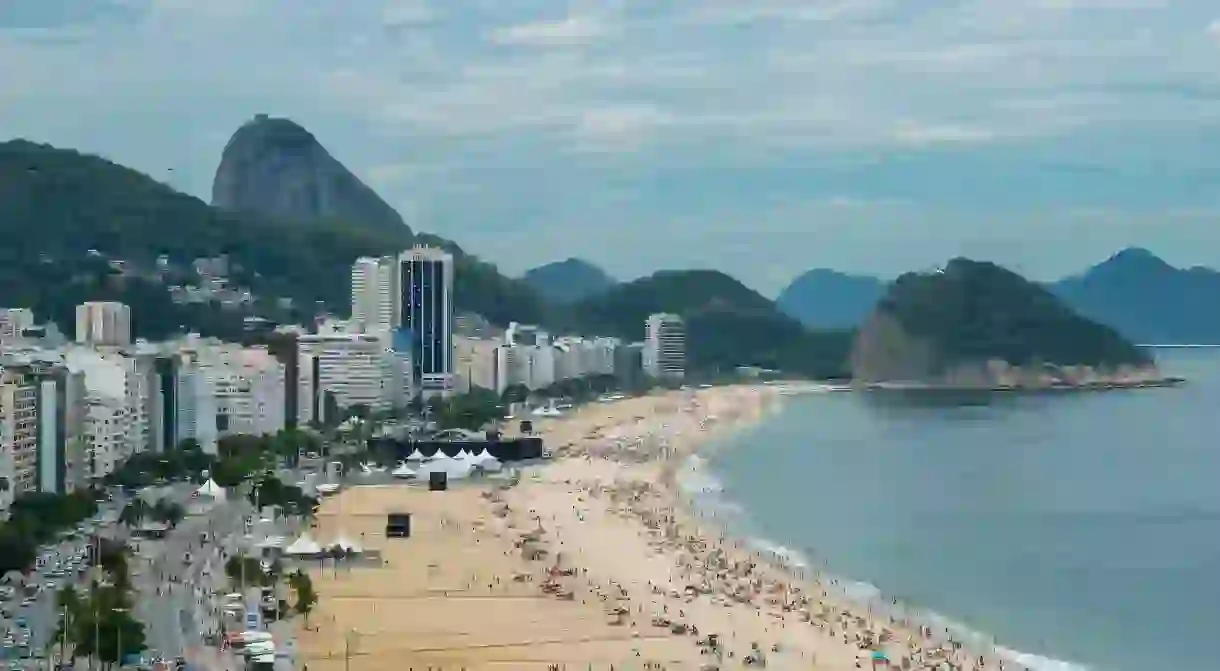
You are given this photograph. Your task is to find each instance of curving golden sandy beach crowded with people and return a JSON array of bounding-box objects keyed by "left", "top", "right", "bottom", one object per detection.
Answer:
[{"left": 298, "top": 387, "right": 1017, "bottom": 671}]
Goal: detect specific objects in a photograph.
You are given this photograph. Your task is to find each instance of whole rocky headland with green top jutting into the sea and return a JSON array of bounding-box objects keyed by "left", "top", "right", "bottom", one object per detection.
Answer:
[{"left": 850, "top": 259, "right": 1181, "bottom": 390}]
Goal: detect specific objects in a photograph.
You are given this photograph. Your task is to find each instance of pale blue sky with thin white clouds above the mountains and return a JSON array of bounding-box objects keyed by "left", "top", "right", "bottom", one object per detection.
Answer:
[{"left": 0, "top": 0, "right": 1220, "bottom": 295}]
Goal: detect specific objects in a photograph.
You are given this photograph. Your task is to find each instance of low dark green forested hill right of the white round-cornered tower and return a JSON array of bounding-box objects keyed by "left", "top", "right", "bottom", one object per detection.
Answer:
[{"left": 571, "top": 271, "right": 852, "bottom": 377}]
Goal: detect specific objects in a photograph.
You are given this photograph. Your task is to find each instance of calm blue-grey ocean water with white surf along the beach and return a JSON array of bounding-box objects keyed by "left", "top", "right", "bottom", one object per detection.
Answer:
[{"left": 686, "top": 350, "right": 1220, "bottom": 671}]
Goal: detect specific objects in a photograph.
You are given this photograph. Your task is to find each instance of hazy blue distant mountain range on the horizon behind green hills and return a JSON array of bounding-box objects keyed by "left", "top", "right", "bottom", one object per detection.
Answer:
[{"left": 526, "top": 248, "right": 1220, "bottom": 344}]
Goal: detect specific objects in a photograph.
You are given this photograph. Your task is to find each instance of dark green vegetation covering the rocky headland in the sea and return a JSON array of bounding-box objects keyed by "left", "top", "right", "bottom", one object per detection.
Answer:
[{"left": 878, "top": 259, "right": 1150, "bottom": 366}]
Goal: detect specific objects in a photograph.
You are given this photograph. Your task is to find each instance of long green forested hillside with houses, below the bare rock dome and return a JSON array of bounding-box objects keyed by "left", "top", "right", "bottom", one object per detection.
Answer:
[{"left": 0, "top": 140, "right": 547, "bottom": 338}]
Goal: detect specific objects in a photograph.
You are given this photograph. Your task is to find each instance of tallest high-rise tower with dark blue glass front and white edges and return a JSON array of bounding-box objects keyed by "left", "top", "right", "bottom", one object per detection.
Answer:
[{"left": 394, "top": 246, "right": 454, "bottom": 397}]
